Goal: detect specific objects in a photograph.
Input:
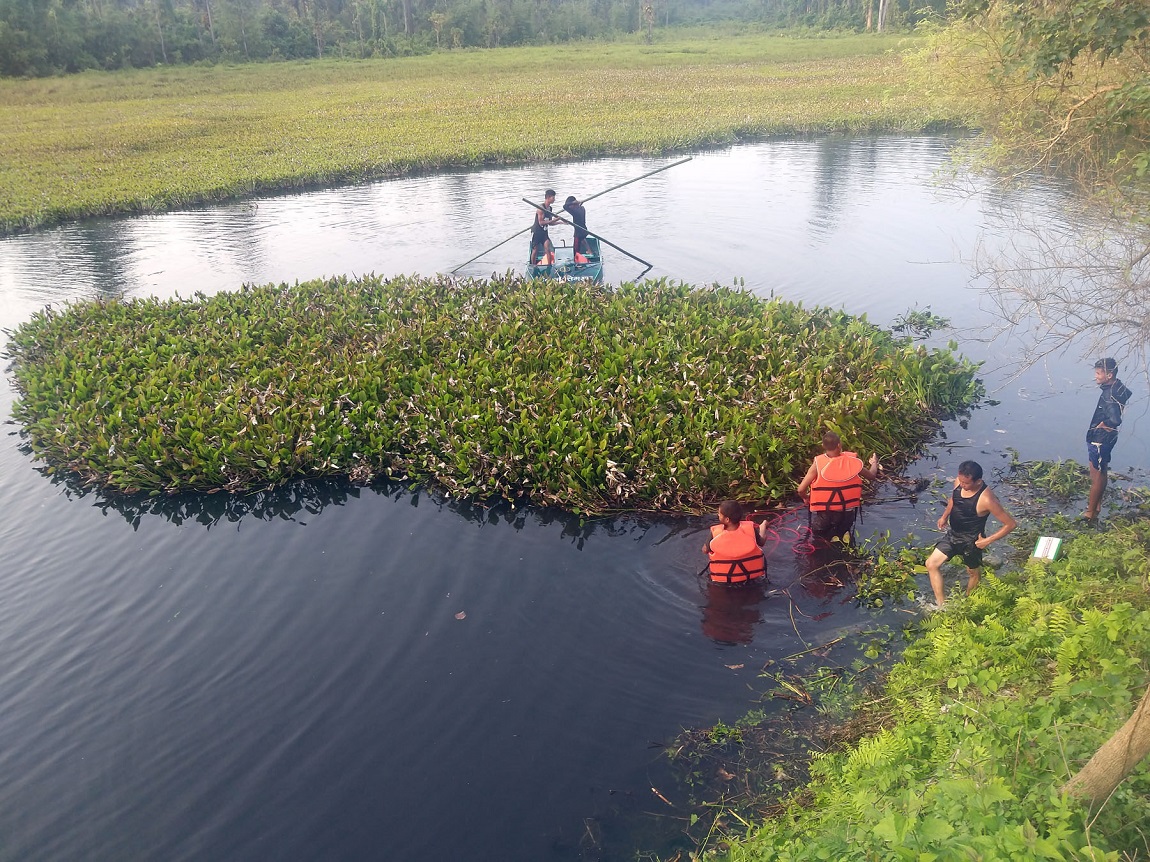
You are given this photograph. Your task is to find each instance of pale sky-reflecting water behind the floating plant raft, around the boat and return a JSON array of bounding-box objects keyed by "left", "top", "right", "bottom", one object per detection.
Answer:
[{"left": 0, "top": 137, "right": 1150, "bottom": 473}]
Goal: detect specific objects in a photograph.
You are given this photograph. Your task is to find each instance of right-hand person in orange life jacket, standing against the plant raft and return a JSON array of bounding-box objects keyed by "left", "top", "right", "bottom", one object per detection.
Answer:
[{"left": 798, "top": 431, "right": 879, "bottom": 539}]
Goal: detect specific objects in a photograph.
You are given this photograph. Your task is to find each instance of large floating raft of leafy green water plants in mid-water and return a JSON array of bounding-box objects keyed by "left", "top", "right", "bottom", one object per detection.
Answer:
[{"left": 8, "top": 275, "right": 982, "bottom": 511}]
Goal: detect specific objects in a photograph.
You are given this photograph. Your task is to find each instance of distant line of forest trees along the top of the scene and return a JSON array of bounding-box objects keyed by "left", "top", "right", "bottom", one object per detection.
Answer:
[{"left": 0, "top": 0, "right": 946, "bottom": 76}]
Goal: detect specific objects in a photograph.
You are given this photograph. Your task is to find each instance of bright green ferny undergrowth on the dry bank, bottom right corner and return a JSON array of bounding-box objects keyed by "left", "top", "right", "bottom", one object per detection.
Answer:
[{"left": 690, "top": 521, "right": 1150, "bottom": 862}]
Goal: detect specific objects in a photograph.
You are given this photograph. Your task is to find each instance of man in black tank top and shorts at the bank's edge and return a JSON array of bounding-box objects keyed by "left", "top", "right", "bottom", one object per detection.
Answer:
[{"left": 927, "top": 461, "right": 1018, "bottom": 607}]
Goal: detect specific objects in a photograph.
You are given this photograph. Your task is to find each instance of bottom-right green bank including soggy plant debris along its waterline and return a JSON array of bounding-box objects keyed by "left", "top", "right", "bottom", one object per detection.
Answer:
[{"left": 660, "top": 516, "right": 1150, "bottom": 862}]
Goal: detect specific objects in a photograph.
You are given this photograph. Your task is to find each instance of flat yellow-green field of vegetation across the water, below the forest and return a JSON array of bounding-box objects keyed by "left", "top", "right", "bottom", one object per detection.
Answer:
[{"left": 0, "top": 32, "right": 948, "bottom": 231}]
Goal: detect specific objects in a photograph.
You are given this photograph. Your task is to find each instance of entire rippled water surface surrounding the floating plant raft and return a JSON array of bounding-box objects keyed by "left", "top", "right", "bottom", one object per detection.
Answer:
[{"left": 0, "top": 138, "right": 1150, "bottom": 862}]
